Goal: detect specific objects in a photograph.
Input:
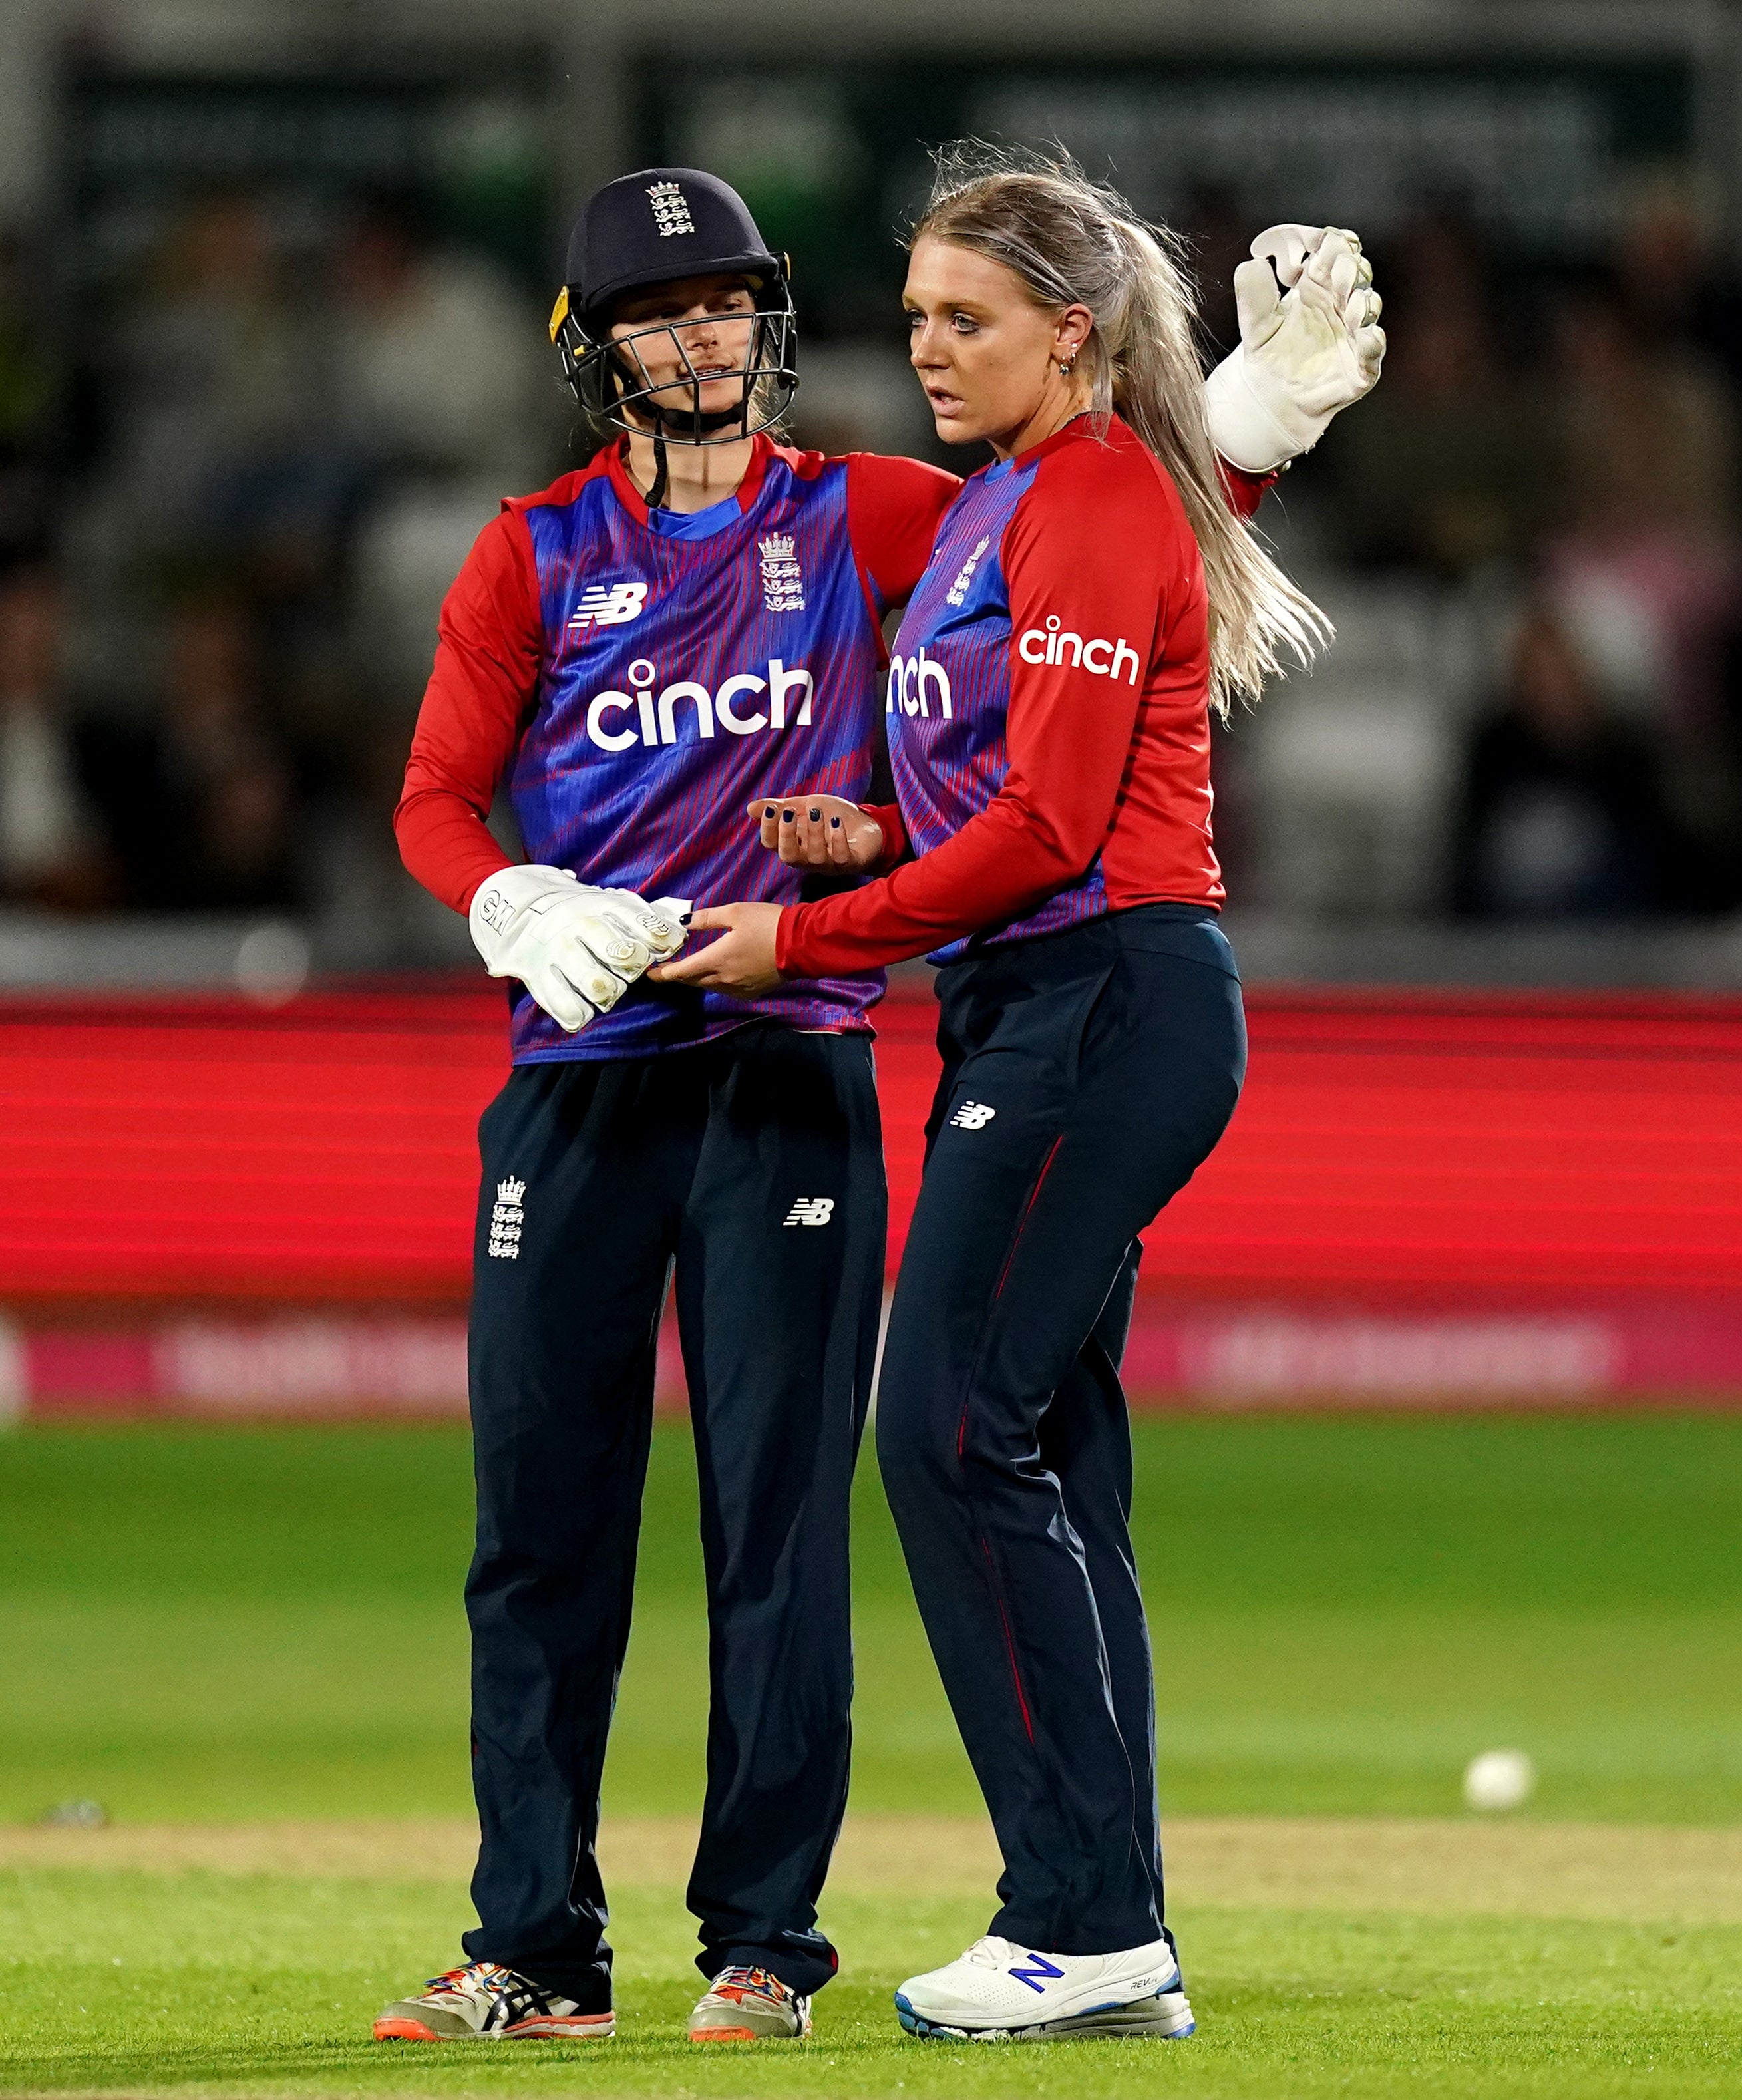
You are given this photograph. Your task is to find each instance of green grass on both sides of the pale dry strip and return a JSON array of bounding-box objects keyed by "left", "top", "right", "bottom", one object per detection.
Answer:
[{"left": 0, "top": 1413, "right": 1742, "bottom": 2100}]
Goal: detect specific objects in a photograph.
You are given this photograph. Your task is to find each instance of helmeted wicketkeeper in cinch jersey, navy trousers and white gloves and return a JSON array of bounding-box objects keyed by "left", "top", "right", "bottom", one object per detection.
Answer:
[{"left": 376, "top": 168, "right": 1385, "bottom": 2041}]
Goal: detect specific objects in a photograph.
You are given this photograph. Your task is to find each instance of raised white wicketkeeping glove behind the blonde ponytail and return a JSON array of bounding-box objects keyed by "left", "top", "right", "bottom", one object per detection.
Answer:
[{"left": 1207, "top": 227, "right": 1385, "bottom": 474}]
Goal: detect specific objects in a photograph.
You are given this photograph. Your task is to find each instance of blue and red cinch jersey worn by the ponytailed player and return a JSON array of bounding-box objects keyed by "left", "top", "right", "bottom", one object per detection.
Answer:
[{"left": 779, "top": 416, "right": 1242, "bottom": 977}]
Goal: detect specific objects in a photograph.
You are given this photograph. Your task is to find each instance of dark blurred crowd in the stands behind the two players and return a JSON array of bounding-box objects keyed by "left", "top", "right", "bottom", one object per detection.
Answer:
[{"left": 0, "top": 0, "right": 1742, "bottom": 987}]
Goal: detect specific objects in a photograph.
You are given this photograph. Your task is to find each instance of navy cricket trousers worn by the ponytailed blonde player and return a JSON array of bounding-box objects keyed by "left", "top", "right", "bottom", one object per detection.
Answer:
[{"left": 877, "top": 905, "right": 1247, "bottom": 1955}]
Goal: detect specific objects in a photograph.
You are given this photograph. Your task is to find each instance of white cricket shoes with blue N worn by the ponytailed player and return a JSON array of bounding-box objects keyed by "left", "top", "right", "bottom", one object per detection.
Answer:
[{"left": 896, "top": 1938, "right": 1196, "bottom": 2041}]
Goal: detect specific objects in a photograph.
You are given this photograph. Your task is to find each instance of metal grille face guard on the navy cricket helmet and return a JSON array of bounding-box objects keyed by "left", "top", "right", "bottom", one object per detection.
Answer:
[{"left": 550, "top": 273, "right": 798, "bottom": 445}]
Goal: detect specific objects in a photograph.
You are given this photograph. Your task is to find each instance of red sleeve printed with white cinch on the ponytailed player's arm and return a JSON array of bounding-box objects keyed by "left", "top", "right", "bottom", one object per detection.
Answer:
[{"left": 777, "top": 445, "right": 1188, "bottom": 977}]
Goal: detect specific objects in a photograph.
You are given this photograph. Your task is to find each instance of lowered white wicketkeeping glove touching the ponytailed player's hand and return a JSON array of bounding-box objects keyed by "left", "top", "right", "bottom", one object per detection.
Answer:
[{"left": 468, "top": 867, "right": 691, "bottom": 1035}]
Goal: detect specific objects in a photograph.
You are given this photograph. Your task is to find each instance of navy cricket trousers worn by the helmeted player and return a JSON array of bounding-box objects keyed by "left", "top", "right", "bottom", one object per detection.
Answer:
[{"left": 464, "top": 1023, "right": 886, "bottom": 2012}]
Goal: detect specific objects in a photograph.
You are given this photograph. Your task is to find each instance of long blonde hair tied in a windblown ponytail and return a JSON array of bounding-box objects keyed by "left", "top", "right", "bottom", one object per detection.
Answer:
[{"left": 907, "top": 140, "right": 1333, "bottom": 721}]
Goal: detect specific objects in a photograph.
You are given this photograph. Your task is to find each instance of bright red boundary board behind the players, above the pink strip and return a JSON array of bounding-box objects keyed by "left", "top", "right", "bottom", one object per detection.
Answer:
[{"left": 0, "top": 979, "right": 1742, "bottom": 1317}]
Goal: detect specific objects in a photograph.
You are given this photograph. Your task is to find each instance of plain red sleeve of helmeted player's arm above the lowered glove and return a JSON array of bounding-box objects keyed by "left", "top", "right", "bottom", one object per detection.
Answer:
[{"left": 393, "top": 510, "right": 544, "bottom": 912}]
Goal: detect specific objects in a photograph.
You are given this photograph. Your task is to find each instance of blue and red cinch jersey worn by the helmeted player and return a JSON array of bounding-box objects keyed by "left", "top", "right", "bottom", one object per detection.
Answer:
[{"left": 395, "top": 439, "right": 957, "bottom": 1065}]
